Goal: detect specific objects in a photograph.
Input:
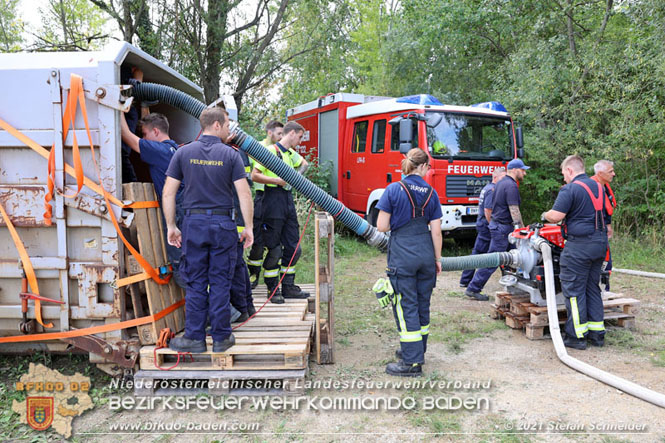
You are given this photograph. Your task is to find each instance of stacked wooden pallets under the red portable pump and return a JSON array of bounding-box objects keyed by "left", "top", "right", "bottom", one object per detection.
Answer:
[{"left": 490, "top": 292, "right": 640, "bottom": 340}]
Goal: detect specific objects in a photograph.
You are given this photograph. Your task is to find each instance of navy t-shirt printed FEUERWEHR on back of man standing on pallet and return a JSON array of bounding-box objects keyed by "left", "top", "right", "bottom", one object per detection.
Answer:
[{"left": 166, "top": 135, "right": 247, "bottom": 209}]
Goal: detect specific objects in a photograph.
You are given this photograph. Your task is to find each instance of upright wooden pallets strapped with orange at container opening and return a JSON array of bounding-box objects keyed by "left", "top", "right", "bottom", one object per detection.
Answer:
[{"left": 123, "top": 183, "right": 185, "bottom": 345}]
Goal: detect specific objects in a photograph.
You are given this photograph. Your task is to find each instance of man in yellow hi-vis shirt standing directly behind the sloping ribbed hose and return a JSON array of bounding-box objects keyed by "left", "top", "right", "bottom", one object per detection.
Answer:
[{"left": 252, "top": 122, "right": 309, "bottom": 304}]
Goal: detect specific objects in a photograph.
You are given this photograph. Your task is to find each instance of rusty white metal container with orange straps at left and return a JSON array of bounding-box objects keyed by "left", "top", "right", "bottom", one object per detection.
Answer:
[{"left": 0, "top": 43, "right": 203, "bottom": 374}]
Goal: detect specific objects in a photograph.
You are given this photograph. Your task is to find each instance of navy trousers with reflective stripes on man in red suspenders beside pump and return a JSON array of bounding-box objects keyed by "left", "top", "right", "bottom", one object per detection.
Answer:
[{"left": 559, "top": 231, "right": 607, "bottom": 340}]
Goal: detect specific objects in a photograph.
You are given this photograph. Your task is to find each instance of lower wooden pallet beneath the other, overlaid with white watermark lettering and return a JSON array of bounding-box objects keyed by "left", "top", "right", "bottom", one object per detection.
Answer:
[{"left": 134, "top": 369, "right": 307, "bottom": 396}]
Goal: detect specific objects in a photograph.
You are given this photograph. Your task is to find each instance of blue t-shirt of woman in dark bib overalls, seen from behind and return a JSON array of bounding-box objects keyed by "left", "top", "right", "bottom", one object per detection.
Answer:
[{"left": 376, "top": 174, "right": 443, "bottom": 231}]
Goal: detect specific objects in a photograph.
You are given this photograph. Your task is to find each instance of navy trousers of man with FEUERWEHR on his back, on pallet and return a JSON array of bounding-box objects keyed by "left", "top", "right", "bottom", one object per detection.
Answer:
[{"left": 180, "top": 214, "right": 238, "bottom": 341}]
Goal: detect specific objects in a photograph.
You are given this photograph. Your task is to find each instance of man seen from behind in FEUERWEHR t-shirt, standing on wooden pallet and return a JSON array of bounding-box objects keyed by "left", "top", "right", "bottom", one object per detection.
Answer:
[{"left": 163, "top": 108, "right": 253, "bottom": 352}]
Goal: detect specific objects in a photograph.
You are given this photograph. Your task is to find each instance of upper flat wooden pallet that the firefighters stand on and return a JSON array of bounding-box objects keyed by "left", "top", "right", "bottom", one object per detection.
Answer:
[{"left": 140, "top": 300, "right": 314, "bottom": 371}]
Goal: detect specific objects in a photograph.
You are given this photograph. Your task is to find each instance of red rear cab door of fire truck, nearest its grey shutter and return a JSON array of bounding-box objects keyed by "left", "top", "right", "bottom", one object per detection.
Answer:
[{"left": 342, "top": 120, "right": 371, "bottom": 213}]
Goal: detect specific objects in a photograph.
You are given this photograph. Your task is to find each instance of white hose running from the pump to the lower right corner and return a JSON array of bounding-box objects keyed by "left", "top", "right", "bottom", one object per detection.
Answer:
[{"left": 536, "top": 240, "right": 665, "bottom": 408}]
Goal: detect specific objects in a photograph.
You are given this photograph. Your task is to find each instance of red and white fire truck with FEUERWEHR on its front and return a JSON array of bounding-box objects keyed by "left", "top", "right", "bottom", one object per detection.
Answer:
[{"left": 286, "top": 93, "right": 524, "bottom": 237}]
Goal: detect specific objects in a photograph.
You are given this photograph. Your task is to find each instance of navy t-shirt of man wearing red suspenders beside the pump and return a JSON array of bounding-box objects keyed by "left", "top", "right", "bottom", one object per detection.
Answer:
[{"left": 552, "top": 174, "right": 605, "bottom": 236}]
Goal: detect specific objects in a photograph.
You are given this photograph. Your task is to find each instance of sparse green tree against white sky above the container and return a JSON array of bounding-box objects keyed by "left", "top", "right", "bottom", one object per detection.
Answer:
[{"left": 33, "top": 0, "right": 108, "bottom": 51}]
